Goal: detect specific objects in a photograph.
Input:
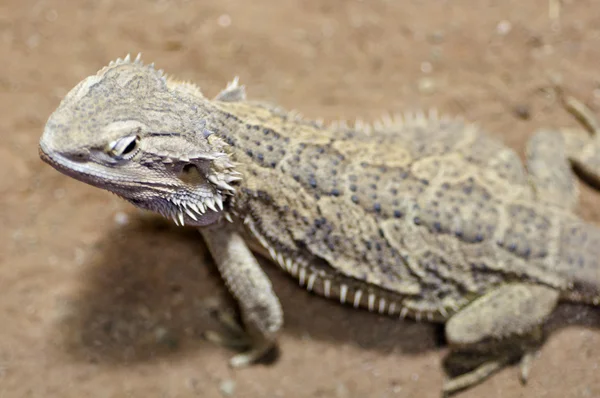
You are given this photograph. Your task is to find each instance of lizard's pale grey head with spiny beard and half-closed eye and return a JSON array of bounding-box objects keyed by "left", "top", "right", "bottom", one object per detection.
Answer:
[{"left": 39, "top": 55, "right": 240, "bottom": 226}]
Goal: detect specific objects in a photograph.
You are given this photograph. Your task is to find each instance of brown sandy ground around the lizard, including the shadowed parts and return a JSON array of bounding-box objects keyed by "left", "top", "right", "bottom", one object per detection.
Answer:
[{"left": 0, "top": 0, "right": 600, "bottom": 398}]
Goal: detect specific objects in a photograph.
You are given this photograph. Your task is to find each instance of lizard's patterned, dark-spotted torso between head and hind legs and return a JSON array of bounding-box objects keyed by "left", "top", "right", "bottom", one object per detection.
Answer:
[{"left": 207, "top": 102, "right": 600, "bottom": 319}]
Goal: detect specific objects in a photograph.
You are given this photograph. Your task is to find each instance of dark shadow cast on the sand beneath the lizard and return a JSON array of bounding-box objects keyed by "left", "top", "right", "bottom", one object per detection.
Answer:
[{"left": 59, "top": 216, "right": 600, "bottom": 370}]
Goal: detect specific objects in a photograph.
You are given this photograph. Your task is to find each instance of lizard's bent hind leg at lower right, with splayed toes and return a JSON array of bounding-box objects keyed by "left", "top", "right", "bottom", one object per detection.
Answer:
[{"left": 443, "top": 283, "right": 559, "bottom": 394}]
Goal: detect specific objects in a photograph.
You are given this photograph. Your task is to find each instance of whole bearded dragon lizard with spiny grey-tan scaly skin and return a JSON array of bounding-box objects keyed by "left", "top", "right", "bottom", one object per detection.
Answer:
[{"left": 40, "top": 57, "right": 600, "bottom": 393}]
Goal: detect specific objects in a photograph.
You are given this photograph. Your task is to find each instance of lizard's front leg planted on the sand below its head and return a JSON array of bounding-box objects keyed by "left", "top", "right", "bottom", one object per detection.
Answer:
[{"left": 200, "top": 223, "right": 283, "bottom": 367}]
